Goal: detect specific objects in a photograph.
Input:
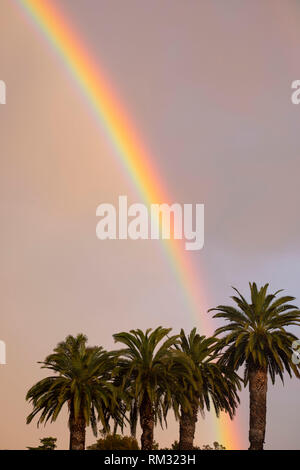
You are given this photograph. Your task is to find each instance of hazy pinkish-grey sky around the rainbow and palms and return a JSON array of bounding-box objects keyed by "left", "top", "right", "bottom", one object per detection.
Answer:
[{"left": 0, "top": 0, "right": 300, "bottom": 449}]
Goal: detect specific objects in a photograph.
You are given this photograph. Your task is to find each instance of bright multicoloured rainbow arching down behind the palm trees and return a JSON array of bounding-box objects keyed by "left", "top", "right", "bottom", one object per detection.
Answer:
[{"left": 17, "top": 0, "right": 240, "bottom": 449}]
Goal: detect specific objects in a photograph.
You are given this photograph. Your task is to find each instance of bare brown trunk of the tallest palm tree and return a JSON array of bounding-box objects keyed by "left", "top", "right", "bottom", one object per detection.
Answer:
[{"left": 249, "top": 366, "right": 268, "bottom": 450}]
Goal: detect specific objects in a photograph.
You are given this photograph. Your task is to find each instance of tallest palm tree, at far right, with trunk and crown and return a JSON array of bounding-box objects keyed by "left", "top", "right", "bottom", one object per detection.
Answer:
[{"left": 211, "top": 283, "right": 300, "bottom": 450}]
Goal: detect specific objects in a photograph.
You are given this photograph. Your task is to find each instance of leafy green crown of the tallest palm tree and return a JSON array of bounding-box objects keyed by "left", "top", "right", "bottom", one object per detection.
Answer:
[{"left": 210, "top": 283, "right": 300, "bottom": 383}]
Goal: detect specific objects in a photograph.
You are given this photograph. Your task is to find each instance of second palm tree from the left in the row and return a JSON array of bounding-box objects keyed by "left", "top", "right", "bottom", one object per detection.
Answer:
[{"left": 113, "top": 326, "right": 185, "bottom": 450}]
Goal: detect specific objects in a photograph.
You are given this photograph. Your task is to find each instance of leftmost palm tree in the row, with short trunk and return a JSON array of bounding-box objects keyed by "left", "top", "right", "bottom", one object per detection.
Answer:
[{"left": 26, "top": 334, "right": 116, "bottom": 450}]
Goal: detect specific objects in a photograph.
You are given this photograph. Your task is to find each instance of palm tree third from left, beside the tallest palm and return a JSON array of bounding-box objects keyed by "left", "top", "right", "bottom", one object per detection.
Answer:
[{"left": 174, "top": 328, "right": 241, "bottom": 450}]
